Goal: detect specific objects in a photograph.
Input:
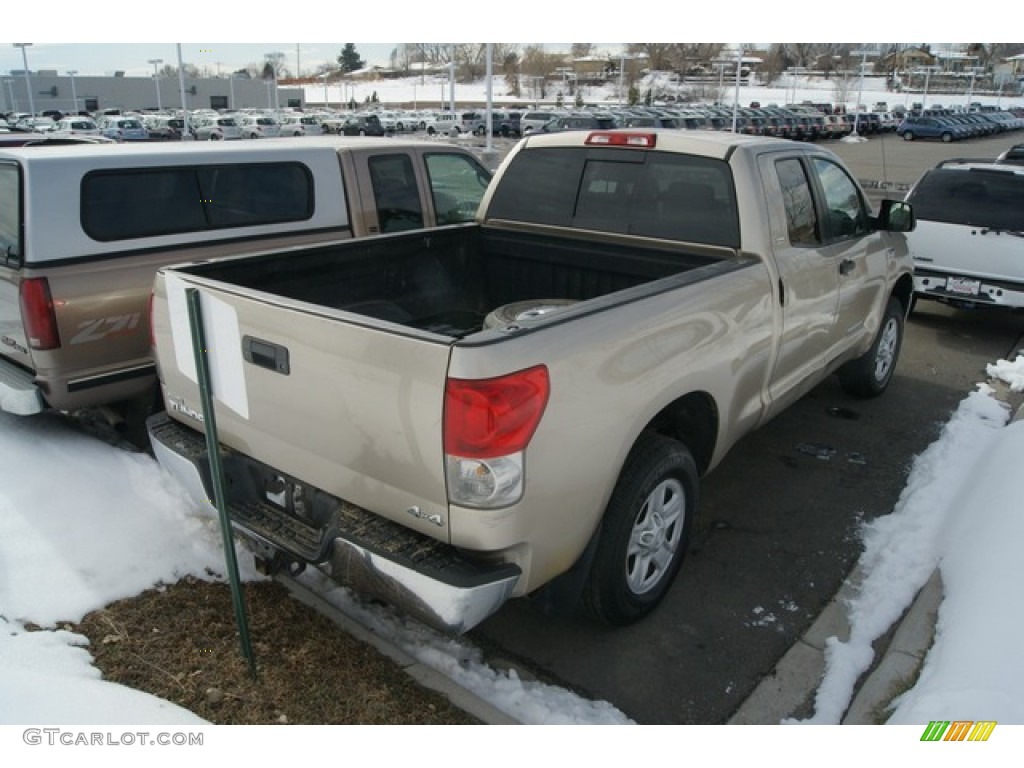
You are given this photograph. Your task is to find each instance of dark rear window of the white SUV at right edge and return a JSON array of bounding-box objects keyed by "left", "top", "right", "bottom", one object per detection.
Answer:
[{"left": 908, "top": 168, "right": 1024, "bottom": 231}]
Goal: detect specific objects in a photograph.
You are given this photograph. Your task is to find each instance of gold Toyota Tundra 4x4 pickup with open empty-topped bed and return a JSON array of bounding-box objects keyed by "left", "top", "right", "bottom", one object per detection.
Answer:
[{"left": 142, "top": 130, "right": 913, "bottom": 633}]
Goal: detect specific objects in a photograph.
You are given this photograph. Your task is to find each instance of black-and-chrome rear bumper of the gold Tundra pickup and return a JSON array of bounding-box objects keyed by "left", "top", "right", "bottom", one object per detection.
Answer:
[{"left": 147, "top": 414, "right": 520, "bottom": 634}]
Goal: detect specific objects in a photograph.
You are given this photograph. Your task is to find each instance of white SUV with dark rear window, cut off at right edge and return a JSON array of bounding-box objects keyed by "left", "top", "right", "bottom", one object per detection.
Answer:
[{"left": 906, "top": 162, "right": 1024, "bottom": 310}]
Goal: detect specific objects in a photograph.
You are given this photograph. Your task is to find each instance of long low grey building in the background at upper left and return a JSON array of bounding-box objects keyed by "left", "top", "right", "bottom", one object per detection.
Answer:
[{"left": 0, "top": 70, "right": 305, "bottom": 115}]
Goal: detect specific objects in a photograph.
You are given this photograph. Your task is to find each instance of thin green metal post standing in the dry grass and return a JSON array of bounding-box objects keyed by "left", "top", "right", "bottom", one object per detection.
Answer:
[{"left": 185, "top": 288, "right": 256, "bottom": 679}]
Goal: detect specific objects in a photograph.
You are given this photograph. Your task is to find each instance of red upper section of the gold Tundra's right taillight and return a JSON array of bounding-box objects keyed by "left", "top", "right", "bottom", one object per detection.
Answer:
[{"left": 444, "top": 366, "right": 550, "bottom": 459}]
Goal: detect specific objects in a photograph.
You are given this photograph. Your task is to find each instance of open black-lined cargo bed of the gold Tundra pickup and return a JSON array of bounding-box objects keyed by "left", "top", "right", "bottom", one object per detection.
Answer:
[{"left": 182, "top": 224, "right": 722, "bottom": 338}]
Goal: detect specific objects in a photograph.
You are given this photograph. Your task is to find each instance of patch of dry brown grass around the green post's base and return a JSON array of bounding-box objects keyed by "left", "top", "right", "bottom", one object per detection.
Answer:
[{"left": 72, "top": 579, "right": 479, "bottom": 725}]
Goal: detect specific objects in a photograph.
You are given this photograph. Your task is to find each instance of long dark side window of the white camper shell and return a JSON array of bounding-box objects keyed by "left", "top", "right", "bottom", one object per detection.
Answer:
[{"left": 82, "top": 163, "right": 313, "bottom": 242}]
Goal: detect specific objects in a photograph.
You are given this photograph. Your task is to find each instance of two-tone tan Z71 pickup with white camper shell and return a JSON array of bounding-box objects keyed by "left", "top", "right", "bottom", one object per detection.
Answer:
[{"left": 0, "top": 138, "right": 490, "bottom": 440}]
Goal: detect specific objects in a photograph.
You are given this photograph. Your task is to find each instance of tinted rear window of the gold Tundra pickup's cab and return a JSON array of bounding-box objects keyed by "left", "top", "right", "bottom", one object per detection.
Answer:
[{"left": 487, "top": 147, "right": 739, "bottom": 248}]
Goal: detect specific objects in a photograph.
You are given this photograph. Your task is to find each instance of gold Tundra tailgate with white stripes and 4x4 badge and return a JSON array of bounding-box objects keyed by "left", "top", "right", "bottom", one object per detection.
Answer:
[{"left": 153, "top": 270, "right": 450, "bottom": 542}]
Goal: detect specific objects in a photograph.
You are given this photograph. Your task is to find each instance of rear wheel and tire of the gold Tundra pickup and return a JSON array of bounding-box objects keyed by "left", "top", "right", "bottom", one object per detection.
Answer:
[{"left": 583, "top": 432, "right": 699, "bottom": 627}]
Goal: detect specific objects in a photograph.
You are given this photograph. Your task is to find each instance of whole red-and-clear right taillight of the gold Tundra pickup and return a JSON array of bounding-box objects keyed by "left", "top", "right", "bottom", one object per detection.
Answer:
[{"left": 444, "top": 366, "right": 550, "bottom": 509}]
